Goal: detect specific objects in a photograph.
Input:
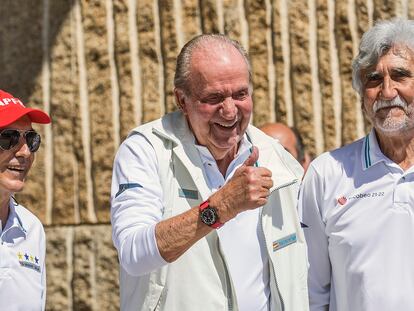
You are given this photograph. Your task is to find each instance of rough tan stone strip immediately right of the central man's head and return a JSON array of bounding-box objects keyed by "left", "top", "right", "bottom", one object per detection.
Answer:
[{"left": 246, "top": 0, "right": 273, "bottom": 126}]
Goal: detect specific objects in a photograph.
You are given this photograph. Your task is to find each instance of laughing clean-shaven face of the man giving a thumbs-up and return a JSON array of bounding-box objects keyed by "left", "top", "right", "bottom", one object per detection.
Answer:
[{"left": 176, "top": 43, "right": 252, "bottom": 160}]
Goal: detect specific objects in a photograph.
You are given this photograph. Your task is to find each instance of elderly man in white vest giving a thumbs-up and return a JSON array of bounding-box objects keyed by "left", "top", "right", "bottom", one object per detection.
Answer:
[{"left": 111, "top": 35, "right": 308, "bottom": 311}]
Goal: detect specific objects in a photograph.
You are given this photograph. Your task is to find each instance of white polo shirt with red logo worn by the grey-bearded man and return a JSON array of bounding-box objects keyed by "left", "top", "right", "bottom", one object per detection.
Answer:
[{"left": 299, "top": 131, "right": 414, "bottom": 311}]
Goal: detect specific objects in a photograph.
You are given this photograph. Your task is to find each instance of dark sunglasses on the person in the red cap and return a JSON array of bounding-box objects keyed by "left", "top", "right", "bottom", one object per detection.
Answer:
[{"left": 0, "top": 129, "right": 41, "bottom": 152}]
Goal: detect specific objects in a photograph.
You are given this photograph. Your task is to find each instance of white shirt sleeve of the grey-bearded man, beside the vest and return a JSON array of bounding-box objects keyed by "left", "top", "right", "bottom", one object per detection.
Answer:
[{"left": 298, "top": 163, "right": 331, "bottom": 311}]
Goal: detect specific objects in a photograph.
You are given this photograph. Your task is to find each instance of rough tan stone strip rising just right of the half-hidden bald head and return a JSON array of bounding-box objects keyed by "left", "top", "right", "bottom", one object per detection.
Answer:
[{"left": 289, "top": 0, "right": 316, "bottom": 154}]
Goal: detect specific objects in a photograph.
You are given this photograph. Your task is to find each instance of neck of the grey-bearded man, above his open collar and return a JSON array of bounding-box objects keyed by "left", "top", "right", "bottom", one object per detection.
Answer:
[{"left": 376, "top": 131, "right": 414, "bottom": 171}]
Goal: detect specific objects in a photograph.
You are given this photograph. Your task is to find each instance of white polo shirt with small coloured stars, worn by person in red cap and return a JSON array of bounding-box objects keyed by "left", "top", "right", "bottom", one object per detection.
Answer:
[{"left": 0, "top": 200, "right": 46, "bottom": 311}]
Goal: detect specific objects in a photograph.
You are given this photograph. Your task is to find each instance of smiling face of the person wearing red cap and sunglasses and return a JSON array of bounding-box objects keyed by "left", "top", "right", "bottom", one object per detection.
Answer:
[{"left": 0, "top": 116, "right": 34, "bottom": 197}]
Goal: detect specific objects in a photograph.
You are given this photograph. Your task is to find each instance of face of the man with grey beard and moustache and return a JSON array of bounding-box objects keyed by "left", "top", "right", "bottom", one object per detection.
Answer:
[{"left": 361, "top": 47, "right": 414, "bottom": 136}]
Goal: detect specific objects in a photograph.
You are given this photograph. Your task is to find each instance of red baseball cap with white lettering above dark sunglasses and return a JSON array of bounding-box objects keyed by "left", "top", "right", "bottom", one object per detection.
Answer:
[{"left": 0, "top": 90, "right": 51, "bottom": 128}]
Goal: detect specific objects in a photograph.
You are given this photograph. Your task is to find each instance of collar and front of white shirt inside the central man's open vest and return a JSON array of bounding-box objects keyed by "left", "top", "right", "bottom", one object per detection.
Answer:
[{"left": 196, "top": 136, "right": 270, "bottom": 311}]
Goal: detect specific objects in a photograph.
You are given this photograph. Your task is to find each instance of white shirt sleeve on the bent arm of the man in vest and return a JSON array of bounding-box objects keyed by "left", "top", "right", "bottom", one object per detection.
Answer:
[{"left": 111, "top": 133, "right": 167, "bottom": 276}]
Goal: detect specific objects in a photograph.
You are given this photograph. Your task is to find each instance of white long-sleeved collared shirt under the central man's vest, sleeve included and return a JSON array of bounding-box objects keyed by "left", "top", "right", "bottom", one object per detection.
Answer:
[{"left": 111, "top": 134, "right": 270, "bottom": 311}]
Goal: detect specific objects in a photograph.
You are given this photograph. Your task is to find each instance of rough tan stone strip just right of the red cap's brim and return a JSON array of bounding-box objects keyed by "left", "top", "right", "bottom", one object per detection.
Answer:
[{"left": 48, "top": 0, "right": 79, "bottom": 224}]
